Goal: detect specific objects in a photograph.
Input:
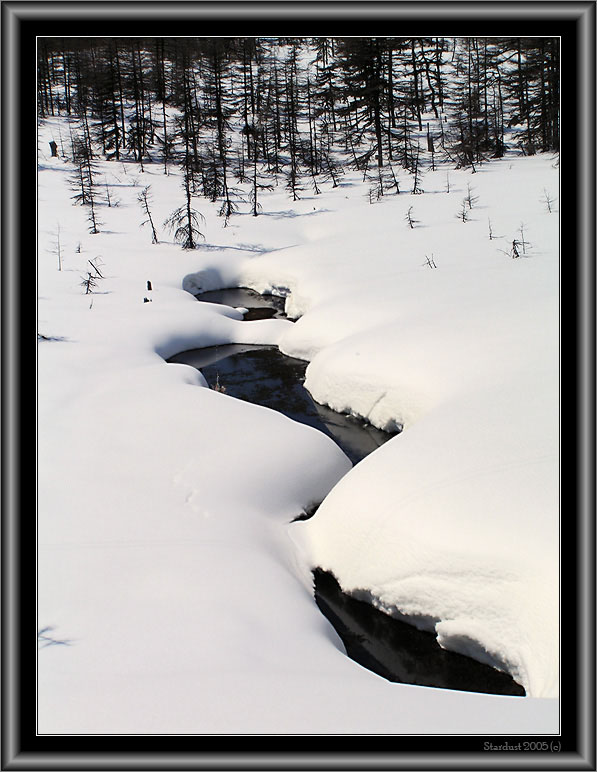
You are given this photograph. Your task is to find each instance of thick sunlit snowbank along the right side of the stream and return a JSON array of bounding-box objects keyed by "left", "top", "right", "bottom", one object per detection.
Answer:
[{"left": 233, "top": 158, "right": 559, "bottom": 697}]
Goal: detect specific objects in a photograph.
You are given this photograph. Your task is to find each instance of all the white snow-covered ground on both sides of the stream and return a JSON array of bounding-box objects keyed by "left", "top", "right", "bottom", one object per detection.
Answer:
[{"left": 38, "top": 119, "right": 559, "bottom": 734}]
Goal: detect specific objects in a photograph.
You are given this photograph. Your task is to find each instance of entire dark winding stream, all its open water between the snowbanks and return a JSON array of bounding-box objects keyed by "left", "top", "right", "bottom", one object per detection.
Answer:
[{"left": 168, "top": 288, "right": 525, "bottom": 696}]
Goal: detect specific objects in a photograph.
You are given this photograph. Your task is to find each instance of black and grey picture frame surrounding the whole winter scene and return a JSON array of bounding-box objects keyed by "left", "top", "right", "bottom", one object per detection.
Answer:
[{"left": 2, "top": 0, "right": 595, "bottom": 770}]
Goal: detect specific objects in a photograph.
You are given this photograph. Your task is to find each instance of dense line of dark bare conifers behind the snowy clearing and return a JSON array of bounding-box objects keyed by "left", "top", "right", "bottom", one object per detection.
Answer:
[{"left": 38, "top": 37, "right": 559, "bottom": 226}]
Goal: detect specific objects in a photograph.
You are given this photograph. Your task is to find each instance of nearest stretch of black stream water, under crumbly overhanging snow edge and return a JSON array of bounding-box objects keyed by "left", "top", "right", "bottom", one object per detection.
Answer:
[{"left": 313, "top": 569, "right": 525, "bottom": 697}]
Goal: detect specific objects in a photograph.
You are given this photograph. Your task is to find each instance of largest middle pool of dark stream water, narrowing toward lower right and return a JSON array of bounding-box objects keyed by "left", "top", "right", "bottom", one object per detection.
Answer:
[{"left": 168, "top": 344, "right": 392, "bottom": 464}]
